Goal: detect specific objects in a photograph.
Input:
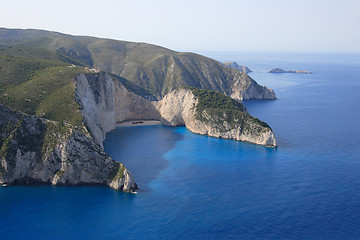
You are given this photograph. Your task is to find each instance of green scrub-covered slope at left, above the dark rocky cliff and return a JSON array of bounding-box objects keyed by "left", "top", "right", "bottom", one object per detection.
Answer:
[{"left": 0, "top": 48, "right": 87, "bottom": 126}]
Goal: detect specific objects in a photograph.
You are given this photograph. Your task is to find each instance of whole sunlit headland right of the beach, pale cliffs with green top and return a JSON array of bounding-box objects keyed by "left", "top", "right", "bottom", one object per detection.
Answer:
[{"left": 155, "top": 88, "right": 277, "bottom": 147}]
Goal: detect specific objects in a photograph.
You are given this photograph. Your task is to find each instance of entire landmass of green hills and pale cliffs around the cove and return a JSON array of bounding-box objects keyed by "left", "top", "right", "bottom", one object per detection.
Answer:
[{"left": 0, "top": 28, "right": 277, "bottom": 192}]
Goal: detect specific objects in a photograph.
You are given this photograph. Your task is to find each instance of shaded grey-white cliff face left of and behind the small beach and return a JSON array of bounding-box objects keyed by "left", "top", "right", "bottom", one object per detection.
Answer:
[{"left": 75, "top": 73, "right": 160, "bottom": 146}]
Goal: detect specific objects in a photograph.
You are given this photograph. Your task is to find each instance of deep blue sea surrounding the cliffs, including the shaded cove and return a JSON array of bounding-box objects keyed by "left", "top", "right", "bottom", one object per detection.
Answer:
[{"left": 0, "top": 52, "right": 360, "bottom": 240}]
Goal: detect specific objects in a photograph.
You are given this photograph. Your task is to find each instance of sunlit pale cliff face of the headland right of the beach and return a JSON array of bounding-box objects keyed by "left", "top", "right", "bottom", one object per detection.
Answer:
[{"left": 154, "top": 89, "right": 277, "bottom": 147}]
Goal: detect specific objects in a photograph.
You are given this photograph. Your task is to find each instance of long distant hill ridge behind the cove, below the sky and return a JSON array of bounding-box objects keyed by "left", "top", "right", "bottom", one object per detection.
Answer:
[{"left": 0, "top": 28, "right": 276, "bottom": 100}]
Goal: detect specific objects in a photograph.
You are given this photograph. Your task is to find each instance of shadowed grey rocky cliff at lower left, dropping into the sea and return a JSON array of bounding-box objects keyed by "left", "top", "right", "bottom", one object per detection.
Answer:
[{"left": 0, "top": 105, "right": 137, "bottom": 192}]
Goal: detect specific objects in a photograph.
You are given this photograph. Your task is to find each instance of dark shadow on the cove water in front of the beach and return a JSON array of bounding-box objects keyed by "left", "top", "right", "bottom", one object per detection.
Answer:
[{"left": 104, "top": 125, "right": 183, "bottom": 190}]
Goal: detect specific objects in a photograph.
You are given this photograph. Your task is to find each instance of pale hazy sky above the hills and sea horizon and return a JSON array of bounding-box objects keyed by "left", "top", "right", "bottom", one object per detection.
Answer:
[{"left": 0, "top": 0, "right": 360, "bottom": 52}]
